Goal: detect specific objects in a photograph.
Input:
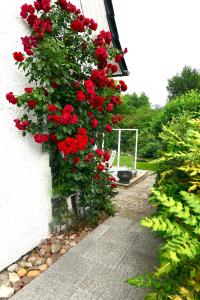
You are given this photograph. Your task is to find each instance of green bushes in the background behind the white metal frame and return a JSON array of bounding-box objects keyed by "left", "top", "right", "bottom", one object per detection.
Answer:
[{"left": 105, "top": 93, "right": 160, "bottom": 158}]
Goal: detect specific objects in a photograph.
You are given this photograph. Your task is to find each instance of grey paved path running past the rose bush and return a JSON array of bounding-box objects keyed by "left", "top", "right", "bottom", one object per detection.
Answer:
[{"left": 11, "top": 176, "right": 159, "bottom": 300}]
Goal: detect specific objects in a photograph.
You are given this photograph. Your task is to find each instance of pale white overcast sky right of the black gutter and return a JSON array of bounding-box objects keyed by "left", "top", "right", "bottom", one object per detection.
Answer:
[{"left": 113, "top": 0, "right": 200, "bottom": 105}]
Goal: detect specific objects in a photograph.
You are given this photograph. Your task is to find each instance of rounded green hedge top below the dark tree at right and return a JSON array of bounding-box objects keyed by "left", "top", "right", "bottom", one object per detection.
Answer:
[{"left": 152, "top": 91, "right": 200, "bottom": 136}]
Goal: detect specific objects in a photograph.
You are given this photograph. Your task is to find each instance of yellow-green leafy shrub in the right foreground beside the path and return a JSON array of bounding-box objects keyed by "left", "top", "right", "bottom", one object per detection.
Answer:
[{"left": 129, "top": 118, "right": 200, "bottom": 300}]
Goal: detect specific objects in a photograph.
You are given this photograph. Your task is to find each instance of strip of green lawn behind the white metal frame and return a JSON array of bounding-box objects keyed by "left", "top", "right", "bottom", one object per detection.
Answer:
[{"left": 113, "top": 154, "right": 158, "bottom": 171}]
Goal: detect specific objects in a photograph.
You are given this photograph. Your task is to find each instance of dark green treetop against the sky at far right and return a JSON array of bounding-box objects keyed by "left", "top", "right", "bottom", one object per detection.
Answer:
[{"left": 167, "top": 66, "right": 200, "bottom": 101}]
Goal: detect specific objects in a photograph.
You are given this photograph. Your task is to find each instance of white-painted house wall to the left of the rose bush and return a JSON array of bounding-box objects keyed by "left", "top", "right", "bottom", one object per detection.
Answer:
[{"left": 0, "top": 0, "right": 51, "bottom": 270}]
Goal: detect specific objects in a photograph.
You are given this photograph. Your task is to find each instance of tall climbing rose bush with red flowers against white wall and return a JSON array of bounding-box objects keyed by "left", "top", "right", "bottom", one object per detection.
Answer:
[{"left": 6, "top": 0, "right": 127, "bottom": 223}]
